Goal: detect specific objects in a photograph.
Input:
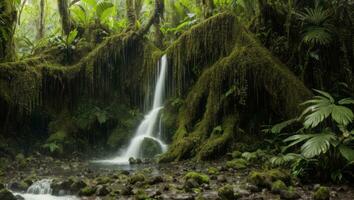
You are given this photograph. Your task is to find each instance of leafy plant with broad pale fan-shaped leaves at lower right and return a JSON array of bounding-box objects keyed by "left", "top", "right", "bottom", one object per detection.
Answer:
[{"left": 270, "top": 90, "right": 354, "bottom": 181}]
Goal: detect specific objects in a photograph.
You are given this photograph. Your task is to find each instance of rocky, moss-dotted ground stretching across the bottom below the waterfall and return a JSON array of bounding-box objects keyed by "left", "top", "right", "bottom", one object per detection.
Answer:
[{"left": 0, "top": 154, "right": 354, "bottom": 200}]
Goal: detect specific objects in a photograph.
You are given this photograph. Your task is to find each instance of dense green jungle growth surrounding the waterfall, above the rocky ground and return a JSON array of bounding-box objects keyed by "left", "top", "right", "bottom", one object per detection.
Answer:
[{"left": 0, "top": 0, "right": 354, "bottom": 199}]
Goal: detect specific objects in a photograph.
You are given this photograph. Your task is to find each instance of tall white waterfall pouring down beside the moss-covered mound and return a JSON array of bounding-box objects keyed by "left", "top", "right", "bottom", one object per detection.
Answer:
[{"left": 99, "top": 55, "right": 167, "bottom": 164}]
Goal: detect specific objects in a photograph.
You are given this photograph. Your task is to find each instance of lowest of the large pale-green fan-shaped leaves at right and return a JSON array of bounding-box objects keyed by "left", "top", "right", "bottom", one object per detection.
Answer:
[{"left": 301, "top": 132, "right": 336, "bottom": 158}]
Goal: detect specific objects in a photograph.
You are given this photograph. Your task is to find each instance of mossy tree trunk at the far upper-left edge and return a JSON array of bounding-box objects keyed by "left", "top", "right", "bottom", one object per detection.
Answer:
[{"left": 0, "top": 0, "right": 17, "bottom": 62}]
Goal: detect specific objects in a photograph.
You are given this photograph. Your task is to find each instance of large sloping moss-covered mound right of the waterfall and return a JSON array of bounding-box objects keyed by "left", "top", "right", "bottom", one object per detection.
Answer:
[{"left": 161, "top": 14, "right": 311, "bottom": 162}]
